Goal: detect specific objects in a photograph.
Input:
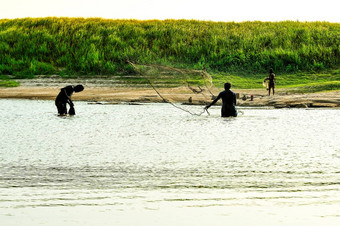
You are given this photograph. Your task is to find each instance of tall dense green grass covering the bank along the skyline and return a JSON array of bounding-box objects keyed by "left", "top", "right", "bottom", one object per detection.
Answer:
[{"left": 0, "top": 18, "right": 340, "bottom": 78}]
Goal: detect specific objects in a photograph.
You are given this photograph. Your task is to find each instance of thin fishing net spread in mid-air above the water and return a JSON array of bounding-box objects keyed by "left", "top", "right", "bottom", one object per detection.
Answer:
[{"left": 128, "top": 61, "right": 217, "bottom": 115}]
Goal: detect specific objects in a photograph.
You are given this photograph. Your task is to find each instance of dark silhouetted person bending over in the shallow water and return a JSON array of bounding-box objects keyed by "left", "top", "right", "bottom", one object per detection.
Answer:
[{"left": 55, "top": 85, "right": 84, "bottom": 115}]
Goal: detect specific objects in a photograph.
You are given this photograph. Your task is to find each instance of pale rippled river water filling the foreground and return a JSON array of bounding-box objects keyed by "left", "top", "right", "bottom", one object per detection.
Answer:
[{"left": 0, "top": 99, "right": 340, "bottom": 226}]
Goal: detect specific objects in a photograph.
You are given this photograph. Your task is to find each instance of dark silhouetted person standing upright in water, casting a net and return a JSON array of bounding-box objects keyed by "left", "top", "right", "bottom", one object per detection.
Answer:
[{"left": 205, "top": 82, "right": 237, "bottom": 117}]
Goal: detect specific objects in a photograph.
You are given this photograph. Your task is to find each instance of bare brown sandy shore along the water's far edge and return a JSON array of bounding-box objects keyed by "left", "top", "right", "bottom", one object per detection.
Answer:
[{"left": 0, "top": 78, "right": 340, "bottom": 108}]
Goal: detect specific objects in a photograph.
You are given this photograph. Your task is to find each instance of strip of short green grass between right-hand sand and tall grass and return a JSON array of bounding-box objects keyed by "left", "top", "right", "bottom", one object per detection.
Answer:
[{"left": 113, "top": 67, "right": 340, "bottom": 93}]
